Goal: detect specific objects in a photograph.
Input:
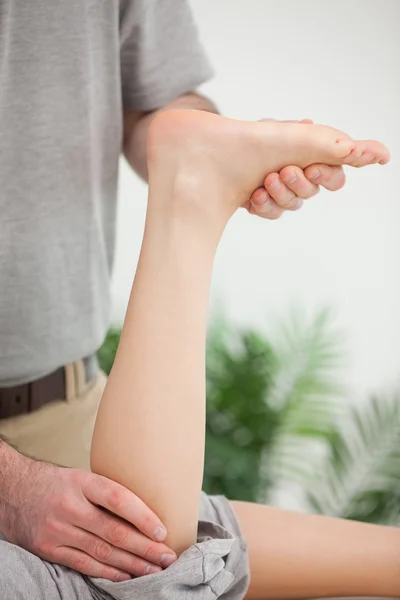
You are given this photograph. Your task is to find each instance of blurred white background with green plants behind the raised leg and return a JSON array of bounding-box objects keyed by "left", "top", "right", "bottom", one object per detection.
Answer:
[{"left": 100, "top": 0, "right": 400, "bottom": 523}]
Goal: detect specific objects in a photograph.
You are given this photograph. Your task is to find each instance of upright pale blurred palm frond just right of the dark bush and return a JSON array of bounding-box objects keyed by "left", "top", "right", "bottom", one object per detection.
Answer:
[{"left": 261, "top": 309, "right": 346, "bottom": 501}]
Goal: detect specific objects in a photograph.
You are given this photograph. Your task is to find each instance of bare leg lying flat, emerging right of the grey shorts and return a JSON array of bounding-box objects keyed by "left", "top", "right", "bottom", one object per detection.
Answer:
[{"left": 232, "top": 502, "right": 400, "bottom": 600}]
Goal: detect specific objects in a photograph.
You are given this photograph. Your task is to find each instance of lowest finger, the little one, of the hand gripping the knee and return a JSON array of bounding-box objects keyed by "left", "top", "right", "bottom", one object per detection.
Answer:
[{"left": 52, "top": 546, "right": 132, "bottom": 581}]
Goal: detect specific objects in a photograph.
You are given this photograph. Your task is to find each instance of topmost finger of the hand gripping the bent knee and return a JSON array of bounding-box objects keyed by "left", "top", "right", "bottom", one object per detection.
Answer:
[{"left": 82, "top": 473, "right": 167, "bottom": 542}]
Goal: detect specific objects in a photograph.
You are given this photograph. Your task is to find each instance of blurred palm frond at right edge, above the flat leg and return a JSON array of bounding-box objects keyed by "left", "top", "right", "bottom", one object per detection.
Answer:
[{"left": 308, "top": 393, "right": 400, "bottom": 523}]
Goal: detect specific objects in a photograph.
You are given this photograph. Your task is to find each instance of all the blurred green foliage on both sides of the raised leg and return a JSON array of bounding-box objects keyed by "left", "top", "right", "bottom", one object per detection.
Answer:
[{"left": 99, "top": 311, "right": 400, "bottom": 524}]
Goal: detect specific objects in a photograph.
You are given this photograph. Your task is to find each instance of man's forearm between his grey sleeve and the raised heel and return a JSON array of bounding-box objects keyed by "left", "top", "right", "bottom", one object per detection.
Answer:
[{"left": 124, "top": 93, "right": 218, "bottom": 181}]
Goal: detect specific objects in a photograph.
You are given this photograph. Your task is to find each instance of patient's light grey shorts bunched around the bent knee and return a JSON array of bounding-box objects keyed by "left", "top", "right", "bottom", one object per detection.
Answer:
[{"left": 0, "top": 494, "right": 249, "bottom": 600}]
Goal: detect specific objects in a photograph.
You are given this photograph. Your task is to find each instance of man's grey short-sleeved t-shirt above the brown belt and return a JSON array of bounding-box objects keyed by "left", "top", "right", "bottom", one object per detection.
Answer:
[{"left": 0, "top": 0, "right": 212, "bottom": 387}]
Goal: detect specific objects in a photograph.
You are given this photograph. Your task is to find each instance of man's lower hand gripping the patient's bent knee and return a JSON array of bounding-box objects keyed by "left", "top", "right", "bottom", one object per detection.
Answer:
[{"left": 0, "top": 451, "right": 176, "bottom": 581}]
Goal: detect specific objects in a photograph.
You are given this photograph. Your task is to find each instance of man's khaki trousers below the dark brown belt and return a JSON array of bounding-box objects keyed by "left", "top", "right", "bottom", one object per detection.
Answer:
[{"left": 0, "top": 361, "right": 106, "bottom": 470}]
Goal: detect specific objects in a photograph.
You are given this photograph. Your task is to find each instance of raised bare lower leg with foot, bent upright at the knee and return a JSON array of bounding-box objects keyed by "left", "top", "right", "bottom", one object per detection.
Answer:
[{"left": 92, "top": 111, "right": 394, "bottom": 589}]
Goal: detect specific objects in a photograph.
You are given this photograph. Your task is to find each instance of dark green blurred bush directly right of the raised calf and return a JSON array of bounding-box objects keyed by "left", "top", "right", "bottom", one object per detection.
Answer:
[{"left": 203, "top": 322, "right": 280, "bottom": 501}]
